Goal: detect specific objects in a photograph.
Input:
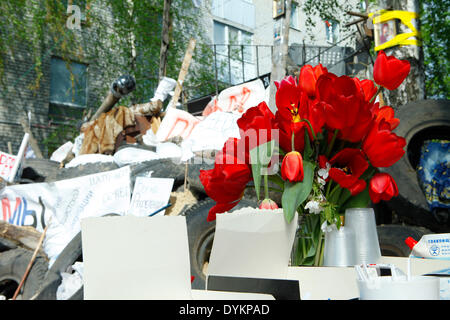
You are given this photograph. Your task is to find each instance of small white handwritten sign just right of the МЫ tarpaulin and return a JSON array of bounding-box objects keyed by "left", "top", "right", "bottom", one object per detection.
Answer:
[{"left": 128, "top": 177, "right": 174, "bottom": 217}]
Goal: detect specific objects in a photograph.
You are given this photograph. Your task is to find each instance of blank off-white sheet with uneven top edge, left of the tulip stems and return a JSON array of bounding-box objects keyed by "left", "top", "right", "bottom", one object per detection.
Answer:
[{"left": 208, "top": 208, "right": 298, "bottom": 279}]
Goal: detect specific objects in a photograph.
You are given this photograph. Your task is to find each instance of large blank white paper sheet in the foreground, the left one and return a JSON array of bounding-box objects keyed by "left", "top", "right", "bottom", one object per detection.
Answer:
[{"left": 81, "top": 216, "right": 192, "bottom": 300}]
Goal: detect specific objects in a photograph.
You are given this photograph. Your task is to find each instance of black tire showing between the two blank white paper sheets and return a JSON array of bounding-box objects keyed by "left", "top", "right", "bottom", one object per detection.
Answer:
[{"left": 182, "top": 198, "right": 257, "bottom": 289}]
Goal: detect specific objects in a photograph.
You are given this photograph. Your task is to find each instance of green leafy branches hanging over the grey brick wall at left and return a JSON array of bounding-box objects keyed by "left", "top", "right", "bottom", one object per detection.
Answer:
[{"left": 0, "top": 0, "right": 214, "bottom": 154}]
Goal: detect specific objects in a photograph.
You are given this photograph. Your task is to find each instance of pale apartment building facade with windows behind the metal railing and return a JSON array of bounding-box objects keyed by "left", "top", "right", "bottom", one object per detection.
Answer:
[{"left": 198, "top": 0, "right": 365, "bottom": 84}]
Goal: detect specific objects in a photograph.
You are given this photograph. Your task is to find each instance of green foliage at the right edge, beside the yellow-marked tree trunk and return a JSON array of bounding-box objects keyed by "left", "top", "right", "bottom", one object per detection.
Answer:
[{"left": 420, "top": 0, "right": 450, "bottom": 99}]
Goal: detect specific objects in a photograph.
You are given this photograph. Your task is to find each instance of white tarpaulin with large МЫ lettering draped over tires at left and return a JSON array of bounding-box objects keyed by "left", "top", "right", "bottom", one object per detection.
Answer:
[{"left": 0, "top": 166, "right": 131, "bottom": 264}]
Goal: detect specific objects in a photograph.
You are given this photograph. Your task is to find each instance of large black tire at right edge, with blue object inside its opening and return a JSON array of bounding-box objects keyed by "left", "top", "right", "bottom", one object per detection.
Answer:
[{"left": 380, "top": 100, "right": 450, "bottom": 232}]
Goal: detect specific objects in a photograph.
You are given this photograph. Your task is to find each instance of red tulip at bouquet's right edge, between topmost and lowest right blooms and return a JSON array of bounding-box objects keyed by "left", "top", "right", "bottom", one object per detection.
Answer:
[{"left": 362, "top": 119, "right": 406, "bottom": 167}]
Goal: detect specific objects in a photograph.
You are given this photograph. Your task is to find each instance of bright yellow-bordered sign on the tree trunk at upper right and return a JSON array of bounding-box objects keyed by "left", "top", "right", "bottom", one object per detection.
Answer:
[{"left": 369, "top": 10, "right": 422, "bottom": 51}]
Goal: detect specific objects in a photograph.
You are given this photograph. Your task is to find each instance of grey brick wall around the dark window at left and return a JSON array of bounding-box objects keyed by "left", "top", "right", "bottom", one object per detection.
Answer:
[{"left": 0, "top": 2, "right": 118, "bottom": 157}]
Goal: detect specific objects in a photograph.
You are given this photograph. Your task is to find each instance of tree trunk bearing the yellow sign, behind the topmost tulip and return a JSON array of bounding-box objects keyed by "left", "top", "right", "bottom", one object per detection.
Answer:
[{"left": 370, "top": 0, "right": 425, "bottom": 109}]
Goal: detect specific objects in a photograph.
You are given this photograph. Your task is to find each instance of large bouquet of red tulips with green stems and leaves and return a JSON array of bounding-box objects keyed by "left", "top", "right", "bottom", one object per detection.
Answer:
[{"left": 200, "top": 51, "right": 410, "bottom": 265}]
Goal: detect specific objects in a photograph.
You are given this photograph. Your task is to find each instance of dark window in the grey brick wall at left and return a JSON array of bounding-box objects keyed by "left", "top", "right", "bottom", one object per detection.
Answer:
[{"left": 49, "top": 57, "right": 87, "bottom": 121}]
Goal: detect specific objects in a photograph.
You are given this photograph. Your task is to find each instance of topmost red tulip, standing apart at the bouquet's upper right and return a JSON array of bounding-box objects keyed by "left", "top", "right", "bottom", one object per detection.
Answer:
[{"left": 373, "top": 51, "right": 411, "bottom": 90}]
